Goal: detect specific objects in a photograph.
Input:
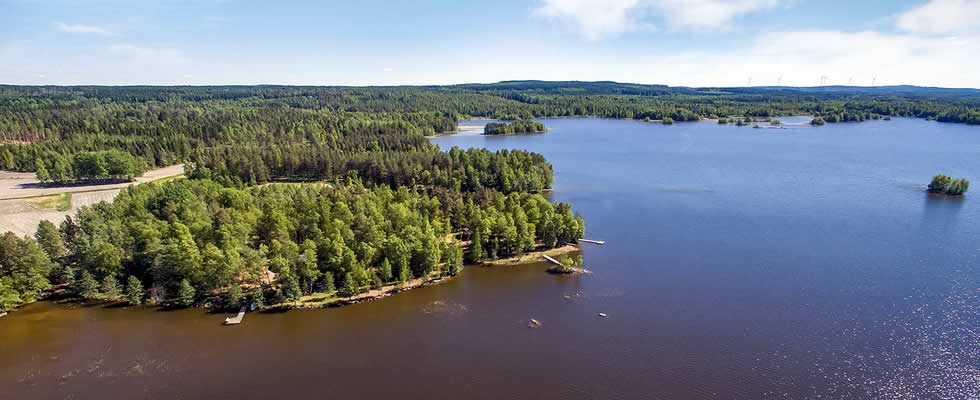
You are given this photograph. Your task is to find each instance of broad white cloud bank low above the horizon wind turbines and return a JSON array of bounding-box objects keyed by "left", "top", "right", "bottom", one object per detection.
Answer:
[{"left": 632, "top": 31, "right": 980, "bottom": 87}]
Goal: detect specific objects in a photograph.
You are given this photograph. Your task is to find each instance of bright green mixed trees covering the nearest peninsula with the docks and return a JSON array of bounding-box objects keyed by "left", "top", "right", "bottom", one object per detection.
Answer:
[{"left": 0, "top": 179, "right": 585, "bottom": 307}]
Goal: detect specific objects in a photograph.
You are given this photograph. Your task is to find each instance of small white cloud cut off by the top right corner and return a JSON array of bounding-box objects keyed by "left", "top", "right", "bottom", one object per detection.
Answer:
[{"left": 896, "top": 0, "right": 980, "bottom": 35}]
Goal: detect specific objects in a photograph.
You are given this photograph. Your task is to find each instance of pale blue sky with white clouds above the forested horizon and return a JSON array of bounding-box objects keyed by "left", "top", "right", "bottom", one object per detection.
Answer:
[{"left": 0, "top": 0, "right": 980, "bottom": 87}]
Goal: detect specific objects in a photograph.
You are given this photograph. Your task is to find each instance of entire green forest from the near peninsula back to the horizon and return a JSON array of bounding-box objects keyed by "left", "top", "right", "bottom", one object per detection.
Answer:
[{"left": 0, "top": 81, "right": 980, "bottom": 310}]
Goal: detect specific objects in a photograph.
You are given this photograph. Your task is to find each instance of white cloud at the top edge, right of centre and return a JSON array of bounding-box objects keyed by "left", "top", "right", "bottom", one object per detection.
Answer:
[{"left": 534, "top": 0, "right": 787, "bottom": 40}]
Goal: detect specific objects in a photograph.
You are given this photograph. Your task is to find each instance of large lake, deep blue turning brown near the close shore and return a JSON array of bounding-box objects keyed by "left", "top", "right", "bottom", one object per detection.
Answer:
[{"left": 0, "top": 119, "right": 980, "bottom": 399}]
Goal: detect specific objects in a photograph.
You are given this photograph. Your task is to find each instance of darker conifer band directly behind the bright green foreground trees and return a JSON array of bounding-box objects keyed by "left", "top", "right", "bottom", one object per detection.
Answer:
[{"left": 188, "top": 144, "right": 553, "bottom": 193}]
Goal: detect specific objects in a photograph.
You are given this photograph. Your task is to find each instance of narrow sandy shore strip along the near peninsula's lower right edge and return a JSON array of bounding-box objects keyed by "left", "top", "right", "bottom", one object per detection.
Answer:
[{"left": 272, "top": 244, "right": 580, "bottom": 312}]
